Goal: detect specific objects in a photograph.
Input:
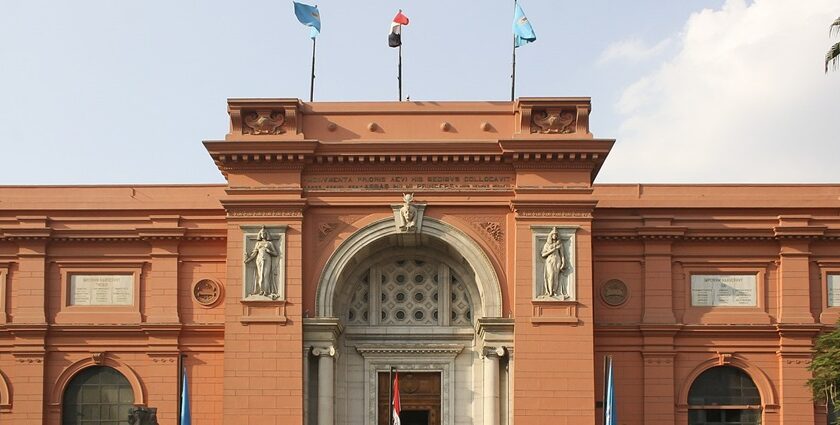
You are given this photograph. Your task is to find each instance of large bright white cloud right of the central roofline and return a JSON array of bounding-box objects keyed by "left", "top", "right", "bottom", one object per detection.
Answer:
[{"left": 599, "top": 0, "right": 840, "bottom": 182}]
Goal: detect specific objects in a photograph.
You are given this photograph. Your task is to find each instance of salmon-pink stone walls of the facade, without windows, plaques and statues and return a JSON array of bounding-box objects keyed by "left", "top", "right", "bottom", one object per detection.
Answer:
[{"left": 0, "top": 98, "right": 840, "bottom": 425}]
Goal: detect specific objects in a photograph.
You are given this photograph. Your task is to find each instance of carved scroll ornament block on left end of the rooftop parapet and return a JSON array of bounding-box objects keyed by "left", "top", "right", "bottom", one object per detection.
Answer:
[{"left": 225, "top": 99, "right": 303, "bottom": 140}]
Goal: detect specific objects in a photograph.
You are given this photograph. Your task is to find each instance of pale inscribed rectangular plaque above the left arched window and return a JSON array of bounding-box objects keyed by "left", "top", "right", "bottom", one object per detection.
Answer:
[{"left": 70, "top": 274, "right": 134, "bottom": 306}]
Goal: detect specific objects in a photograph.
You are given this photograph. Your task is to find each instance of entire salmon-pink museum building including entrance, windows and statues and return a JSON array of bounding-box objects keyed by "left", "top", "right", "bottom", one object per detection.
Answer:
[{"left": 0, "top": 98, "right": 840, "bottom": 425}]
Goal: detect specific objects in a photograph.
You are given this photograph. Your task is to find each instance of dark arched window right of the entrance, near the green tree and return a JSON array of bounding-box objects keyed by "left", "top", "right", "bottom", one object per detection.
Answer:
[{"left": 688, "top": 366, "right": 761, "bottom": 425}]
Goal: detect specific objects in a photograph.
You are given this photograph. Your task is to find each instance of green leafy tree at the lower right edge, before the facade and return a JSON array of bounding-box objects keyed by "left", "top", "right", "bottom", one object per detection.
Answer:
[{"left": 808, "top": 320, "right": 840, "bottom": 424}]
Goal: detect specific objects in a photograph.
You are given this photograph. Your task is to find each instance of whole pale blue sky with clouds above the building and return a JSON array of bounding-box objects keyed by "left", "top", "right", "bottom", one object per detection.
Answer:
[{"left": 0, "top": 0, "right": 840, "bottom": 185}]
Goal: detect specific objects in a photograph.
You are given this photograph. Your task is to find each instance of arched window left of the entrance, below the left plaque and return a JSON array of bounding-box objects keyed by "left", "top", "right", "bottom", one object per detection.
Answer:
[{"left": 61, "top": 366, "right": 134, "bottom": 425}]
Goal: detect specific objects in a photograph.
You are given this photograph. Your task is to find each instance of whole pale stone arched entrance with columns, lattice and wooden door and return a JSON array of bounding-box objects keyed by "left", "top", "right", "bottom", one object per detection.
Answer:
[{"left": 304, "top": 218, "right": 512, "bottom": 425}]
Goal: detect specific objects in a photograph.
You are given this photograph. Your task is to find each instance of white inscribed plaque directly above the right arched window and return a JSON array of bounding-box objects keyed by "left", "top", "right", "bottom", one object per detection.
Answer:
[{"left": 691, "top": 274, "right": 757, "bottom": 307}]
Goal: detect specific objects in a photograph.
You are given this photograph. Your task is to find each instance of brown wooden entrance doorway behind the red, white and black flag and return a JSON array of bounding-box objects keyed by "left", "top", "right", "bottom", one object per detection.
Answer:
[{"left": 377, "top": 371, "right": 441, "bottom": 425}]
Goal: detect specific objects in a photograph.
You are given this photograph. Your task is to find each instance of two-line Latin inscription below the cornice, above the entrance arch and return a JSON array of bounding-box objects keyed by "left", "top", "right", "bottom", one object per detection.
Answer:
[{"left": 303, "top": 175, "right": 514, "bottom": 191}]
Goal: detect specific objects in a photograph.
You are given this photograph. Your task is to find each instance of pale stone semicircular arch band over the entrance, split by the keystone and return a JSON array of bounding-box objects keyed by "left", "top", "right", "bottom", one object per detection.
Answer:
[{"left": 316, "top": 217, "right": 502, "bottom": 318}]
